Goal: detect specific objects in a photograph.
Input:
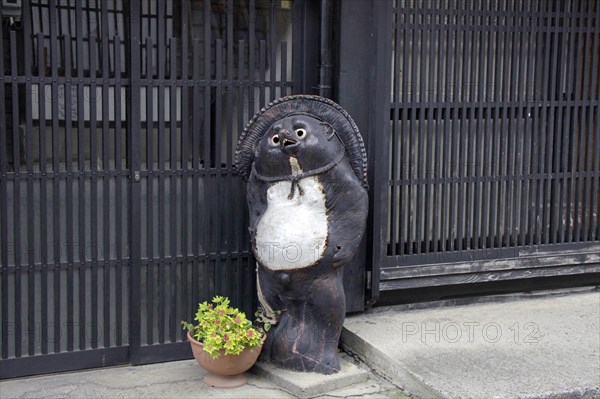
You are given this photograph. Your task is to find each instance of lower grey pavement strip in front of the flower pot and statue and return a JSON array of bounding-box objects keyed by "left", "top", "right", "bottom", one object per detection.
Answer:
[{"left": 0, "top": 358, "right": 407, "bottom": 399}]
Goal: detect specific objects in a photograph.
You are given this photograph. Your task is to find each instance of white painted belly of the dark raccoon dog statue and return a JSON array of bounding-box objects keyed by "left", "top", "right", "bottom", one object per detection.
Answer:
[{"left": 255, "top": 176, "right": 327, "bottom": 270}]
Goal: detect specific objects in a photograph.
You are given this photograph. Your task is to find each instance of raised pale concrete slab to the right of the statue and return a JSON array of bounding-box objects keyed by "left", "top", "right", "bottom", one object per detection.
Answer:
[{"left": 342, "top": 289, "right": 600, "bottom": 398}]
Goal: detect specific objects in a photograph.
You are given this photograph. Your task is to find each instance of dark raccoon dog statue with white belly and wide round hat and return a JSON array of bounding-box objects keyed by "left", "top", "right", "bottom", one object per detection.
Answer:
[{"left": 236, "top": 95, "right": 368, "bottom": 374}]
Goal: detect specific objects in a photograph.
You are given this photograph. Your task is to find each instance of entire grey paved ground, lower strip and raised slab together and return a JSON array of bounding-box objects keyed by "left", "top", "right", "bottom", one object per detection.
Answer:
[{"left": 0, "top": 288, "right": 600, "bottom": 399}]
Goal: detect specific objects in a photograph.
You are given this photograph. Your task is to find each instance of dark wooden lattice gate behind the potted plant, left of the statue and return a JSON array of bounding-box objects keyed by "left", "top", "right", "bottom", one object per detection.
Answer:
[{"left": 0, "top": 0, "right": 318, "bottom": 378}]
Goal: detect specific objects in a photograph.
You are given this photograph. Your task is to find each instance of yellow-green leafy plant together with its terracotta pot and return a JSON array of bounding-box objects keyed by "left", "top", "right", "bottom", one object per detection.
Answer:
[{"left": 181, "top": 296, "right": 265, "bottom": 388}]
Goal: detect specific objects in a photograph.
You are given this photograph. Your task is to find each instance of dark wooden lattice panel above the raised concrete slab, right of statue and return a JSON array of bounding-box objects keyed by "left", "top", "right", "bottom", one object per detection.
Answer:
[{"left": 360, "top": 0, "right": 600, "bottom": 296}]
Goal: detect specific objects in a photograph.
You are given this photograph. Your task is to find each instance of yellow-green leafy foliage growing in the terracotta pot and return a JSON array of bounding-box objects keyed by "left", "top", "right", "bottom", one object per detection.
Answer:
[{"left": 181, "top": 296, "right": 263, "bottom": 359}]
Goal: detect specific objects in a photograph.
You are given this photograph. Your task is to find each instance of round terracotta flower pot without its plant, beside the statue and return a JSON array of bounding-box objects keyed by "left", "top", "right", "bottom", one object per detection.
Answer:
[{"left": 188, "top": 332, "right": 266, "bottom": 388}]
